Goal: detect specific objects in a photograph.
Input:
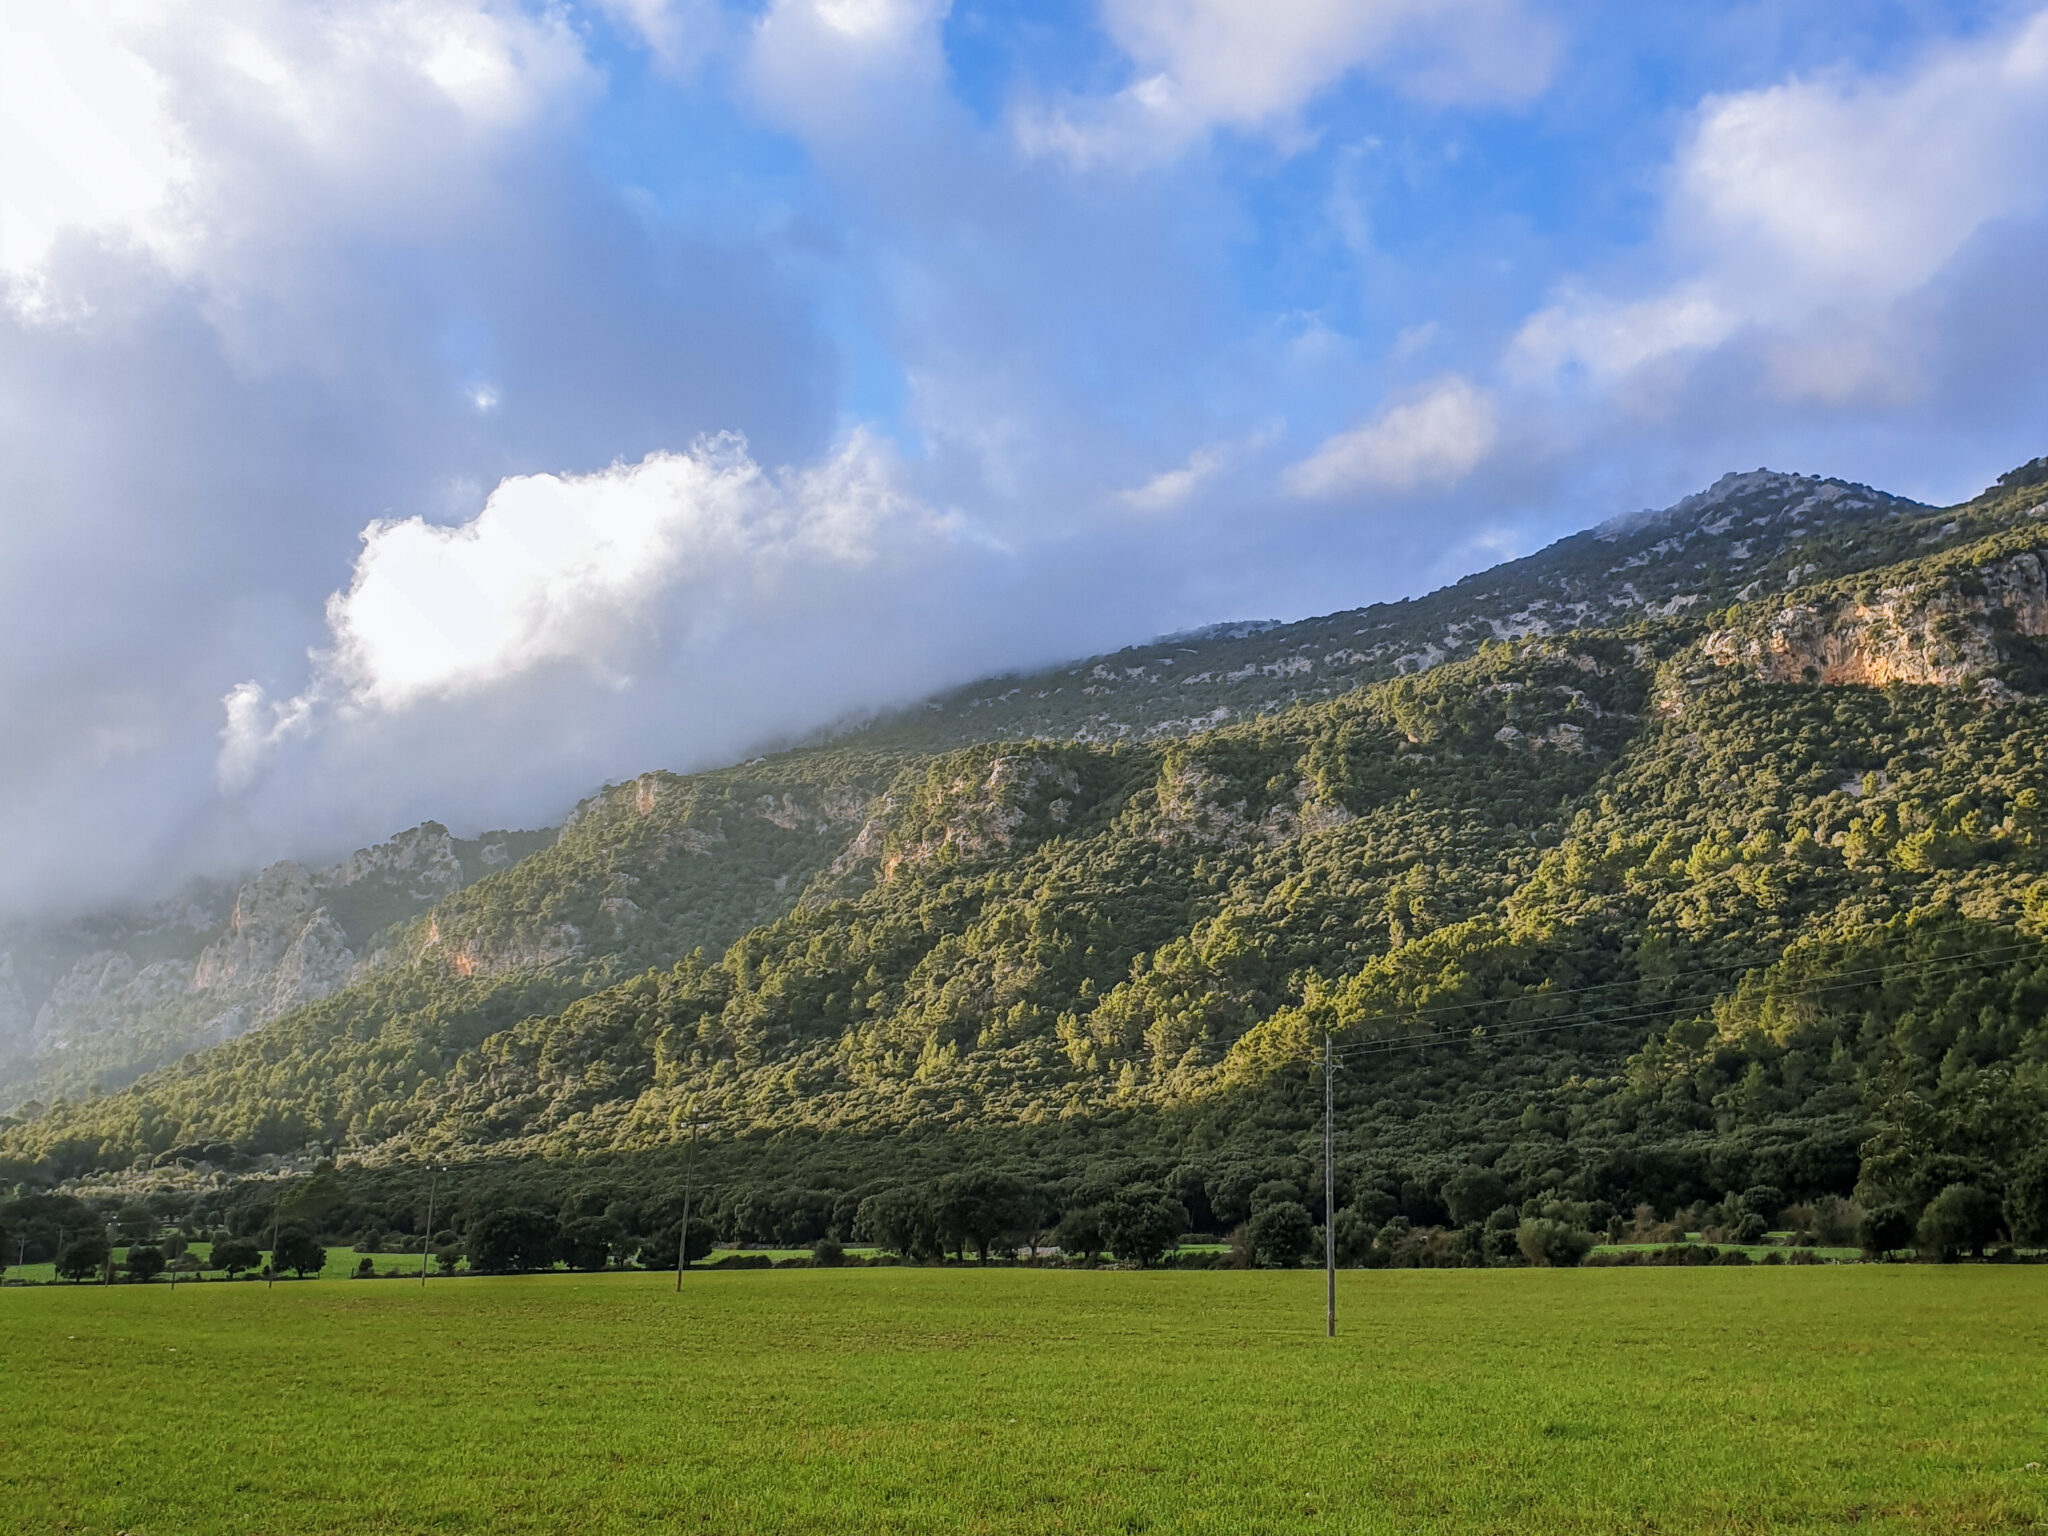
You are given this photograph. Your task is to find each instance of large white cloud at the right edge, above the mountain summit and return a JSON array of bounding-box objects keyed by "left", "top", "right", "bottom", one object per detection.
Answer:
[{"left": 1509, "top": 10, "right": 2048, "bottom": 399}]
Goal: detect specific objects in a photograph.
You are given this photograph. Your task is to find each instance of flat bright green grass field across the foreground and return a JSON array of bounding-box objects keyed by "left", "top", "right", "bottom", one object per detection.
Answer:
[{"left": 0, "top": 1266, "right": 2048, "bottom": 1536}]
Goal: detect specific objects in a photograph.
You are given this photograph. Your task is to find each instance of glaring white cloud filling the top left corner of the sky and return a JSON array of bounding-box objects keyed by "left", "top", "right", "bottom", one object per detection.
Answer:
[{"left": 0, "top": 0, "right": 592, "bottom": 317}]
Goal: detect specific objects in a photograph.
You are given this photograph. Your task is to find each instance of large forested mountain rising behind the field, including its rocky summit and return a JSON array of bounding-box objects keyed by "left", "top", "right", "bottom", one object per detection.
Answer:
[{"left": 0, "top": 460, "right": 2048, "bottom": 1241}]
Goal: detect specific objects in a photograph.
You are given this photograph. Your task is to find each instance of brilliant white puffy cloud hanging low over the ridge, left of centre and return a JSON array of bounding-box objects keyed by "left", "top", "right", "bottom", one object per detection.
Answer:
[{"left": 217, "top": 434, "right": 944, "bottom": 788}]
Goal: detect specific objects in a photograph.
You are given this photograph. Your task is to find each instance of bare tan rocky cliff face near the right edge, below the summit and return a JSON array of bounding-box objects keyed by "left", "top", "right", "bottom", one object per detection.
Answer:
[{"left": 1704, "top": 551, "right": 2048, "bottom": 688}]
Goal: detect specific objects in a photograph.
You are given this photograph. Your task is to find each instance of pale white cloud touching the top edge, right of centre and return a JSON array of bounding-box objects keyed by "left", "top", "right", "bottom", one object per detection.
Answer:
[{"left": 1018, "top": 0, "right": 1556, "bottom": 162}]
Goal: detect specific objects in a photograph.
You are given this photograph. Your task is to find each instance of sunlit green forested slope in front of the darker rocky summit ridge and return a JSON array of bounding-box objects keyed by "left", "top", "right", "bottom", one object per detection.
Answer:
[{"left": 0, "top": 456, "right": 2048, "bottom": 1184}]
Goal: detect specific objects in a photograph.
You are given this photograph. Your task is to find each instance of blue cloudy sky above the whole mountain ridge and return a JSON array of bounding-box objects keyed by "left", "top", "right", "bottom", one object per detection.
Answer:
[{"left": 0, "top": 0, "right": 2048, "bottom": 913}]
